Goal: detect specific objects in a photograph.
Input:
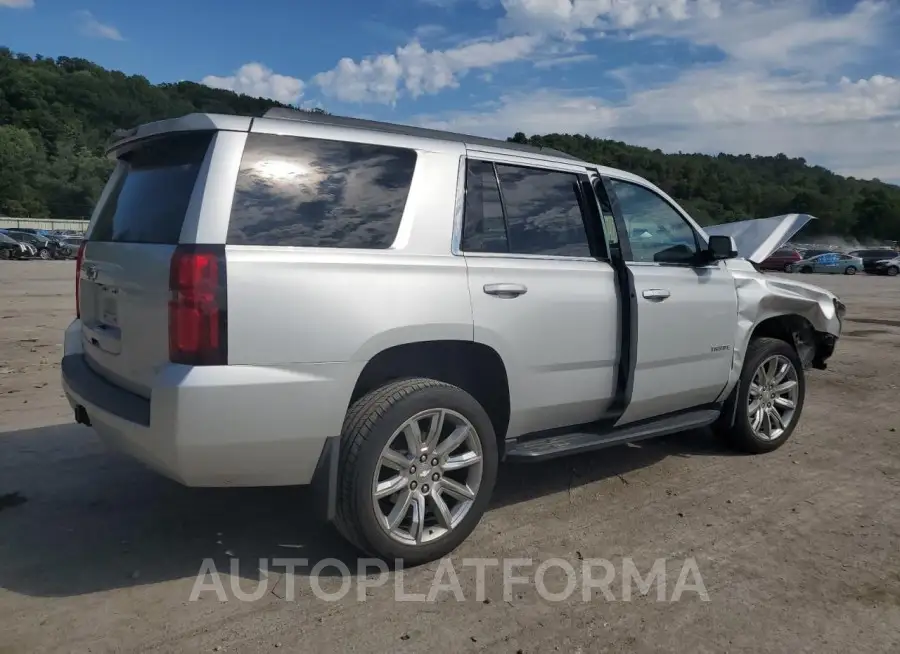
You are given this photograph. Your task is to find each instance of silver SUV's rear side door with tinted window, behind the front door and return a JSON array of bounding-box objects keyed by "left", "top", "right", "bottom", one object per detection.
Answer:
[{"left": 460, "top": 157, "right": 620, "bottom": 437}]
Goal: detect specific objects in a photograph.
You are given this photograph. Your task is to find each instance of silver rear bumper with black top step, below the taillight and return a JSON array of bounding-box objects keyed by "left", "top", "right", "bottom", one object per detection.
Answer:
[{"left": 62, "top": 320, "right": 364, "bottom": 486}]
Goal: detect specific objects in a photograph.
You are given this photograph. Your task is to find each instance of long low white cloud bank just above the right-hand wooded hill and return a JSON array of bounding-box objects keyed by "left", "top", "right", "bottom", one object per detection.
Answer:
[{"left": 418, "top": 69, "right": 900, "bottom": 181}]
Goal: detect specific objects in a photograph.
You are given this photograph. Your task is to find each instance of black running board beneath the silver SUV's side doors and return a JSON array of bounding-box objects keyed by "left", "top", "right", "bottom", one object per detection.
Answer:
[{"left": 506, "top": 409, "right": 720, "bottom": 461}]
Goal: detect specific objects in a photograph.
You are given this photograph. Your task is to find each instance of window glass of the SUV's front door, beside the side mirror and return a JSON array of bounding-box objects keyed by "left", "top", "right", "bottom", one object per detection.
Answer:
[{"left": 610, "top": 179, "right": 698, "bottom": 263}]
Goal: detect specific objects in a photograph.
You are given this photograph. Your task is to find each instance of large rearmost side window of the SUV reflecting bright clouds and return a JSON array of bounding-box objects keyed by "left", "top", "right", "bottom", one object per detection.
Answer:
[{"left": 227, "top": 134, "right": 416, "bottom": 249}]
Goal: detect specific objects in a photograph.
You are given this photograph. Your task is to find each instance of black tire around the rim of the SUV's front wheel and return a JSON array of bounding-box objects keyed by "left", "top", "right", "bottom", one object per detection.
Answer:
[{"left": 713, "top": 338, "right": 806, "bottom": 454}]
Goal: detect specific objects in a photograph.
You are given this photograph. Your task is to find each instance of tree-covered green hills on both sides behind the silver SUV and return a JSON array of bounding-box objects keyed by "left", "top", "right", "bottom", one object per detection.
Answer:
[{"left": 0, "top": 48, "right": 900, "bottom": 240}]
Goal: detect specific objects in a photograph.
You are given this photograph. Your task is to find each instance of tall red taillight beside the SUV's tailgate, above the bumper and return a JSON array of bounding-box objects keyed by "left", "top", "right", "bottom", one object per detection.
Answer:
[{"left": 169, "top": 245, "right": 228, "bottom": 366}]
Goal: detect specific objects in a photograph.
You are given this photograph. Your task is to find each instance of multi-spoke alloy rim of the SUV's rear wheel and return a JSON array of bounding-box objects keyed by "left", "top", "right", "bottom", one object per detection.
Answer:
[{"left": 372, "top": 409, "right": 483, "bottom": 545}]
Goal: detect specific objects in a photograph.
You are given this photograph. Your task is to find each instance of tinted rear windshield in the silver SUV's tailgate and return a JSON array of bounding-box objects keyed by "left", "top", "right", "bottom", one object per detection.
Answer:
[{"left": 88, "top": 132, "right": 213, "bottom": 244}]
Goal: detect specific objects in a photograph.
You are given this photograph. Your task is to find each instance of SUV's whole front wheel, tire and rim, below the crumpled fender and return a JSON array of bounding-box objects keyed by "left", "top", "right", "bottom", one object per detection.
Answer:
[{"left": 714, "top": 338, "right": 806, "bottom": 454}]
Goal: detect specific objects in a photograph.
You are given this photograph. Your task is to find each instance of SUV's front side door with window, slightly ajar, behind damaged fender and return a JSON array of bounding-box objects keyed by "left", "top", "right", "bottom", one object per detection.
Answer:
[{"left": 605, "top": 178, "right": 738, "bottom": 425}]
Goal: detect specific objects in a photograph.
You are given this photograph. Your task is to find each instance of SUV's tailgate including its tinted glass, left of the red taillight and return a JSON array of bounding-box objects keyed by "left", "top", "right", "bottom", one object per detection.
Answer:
[{"left": 79, "top": 131, "right": 216, "bottom": 397}]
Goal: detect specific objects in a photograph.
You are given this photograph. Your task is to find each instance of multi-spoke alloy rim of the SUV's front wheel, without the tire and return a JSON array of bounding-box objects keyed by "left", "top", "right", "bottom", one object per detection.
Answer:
[{"left": 747, "top": 354, "right": 800, "bottom": 441}]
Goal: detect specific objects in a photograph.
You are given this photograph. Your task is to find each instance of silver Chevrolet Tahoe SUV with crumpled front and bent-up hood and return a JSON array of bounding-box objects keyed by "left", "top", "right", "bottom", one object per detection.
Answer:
[{"left": 62, "top": 109, "right": 844, "bottom": 564}]
